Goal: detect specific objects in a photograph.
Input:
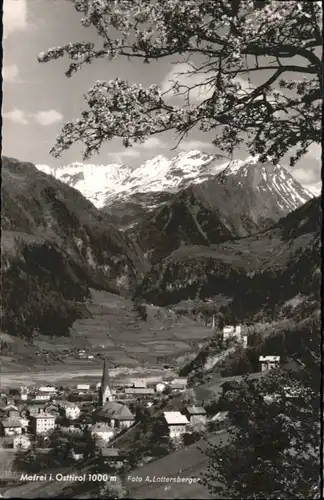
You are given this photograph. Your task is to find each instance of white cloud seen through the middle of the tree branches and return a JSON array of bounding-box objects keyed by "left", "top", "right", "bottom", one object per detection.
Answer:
[{"left": 161, "top": 63, "right": 213, "bottom": 102}]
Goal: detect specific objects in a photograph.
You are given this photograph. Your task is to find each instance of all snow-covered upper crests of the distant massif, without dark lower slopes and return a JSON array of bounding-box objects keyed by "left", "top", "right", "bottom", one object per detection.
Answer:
[{"left": 37, "top": 150, "right": 313, "bottom": 210}]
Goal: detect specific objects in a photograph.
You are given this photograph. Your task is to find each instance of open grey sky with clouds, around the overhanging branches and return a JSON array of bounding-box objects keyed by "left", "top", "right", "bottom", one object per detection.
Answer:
[{"left": 2, "top": 0, "right": 320, "bottom": 191}]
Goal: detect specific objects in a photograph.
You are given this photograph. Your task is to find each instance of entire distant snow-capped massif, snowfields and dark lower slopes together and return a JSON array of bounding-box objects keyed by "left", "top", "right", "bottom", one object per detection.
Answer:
[{"left": 37, "top": 150, "right": 313, "bottom": 261}]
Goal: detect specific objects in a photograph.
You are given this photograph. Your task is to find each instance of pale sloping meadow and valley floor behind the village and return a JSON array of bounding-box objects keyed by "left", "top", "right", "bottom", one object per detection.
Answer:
[{"left": 0, "top": 290, "right": 212, "bottom": 387}]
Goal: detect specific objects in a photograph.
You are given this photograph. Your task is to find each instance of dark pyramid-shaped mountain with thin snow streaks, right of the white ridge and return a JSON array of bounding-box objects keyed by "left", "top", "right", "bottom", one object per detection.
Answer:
[{"left": 132, "top": 160, "right": 311, "bottom": 262}]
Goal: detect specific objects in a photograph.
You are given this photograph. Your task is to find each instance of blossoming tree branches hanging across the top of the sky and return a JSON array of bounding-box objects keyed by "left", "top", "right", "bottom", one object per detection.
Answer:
[{"left": 39, "top": 0, "right": 323, "bottom": 165}]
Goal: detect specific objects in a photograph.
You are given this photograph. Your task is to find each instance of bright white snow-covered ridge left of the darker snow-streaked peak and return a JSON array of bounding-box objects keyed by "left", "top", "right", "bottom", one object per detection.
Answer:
[{"left": 36, "top": 150, "right": 310, "bottom": 214}]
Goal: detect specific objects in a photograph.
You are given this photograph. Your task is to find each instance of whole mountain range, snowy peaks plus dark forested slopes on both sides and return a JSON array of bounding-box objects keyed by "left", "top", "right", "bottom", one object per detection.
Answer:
[{"left": 2, "top": 151, "right": 320, "bottom": 344}]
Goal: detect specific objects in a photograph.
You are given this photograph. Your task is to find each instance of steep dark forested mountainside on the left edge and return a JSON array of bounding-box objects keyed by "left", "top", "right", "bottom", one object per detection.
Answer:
[{"left": 2, "top": 158, "right": 146, "bottom": 334}]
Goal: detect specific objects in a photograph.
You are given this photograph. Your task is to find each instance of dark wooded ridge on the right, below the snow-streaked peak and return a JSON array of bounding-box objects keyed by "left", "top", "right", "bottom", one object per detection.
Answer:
[{"left": 137, "top": 197, "right": 321, "bottom": 315}]
